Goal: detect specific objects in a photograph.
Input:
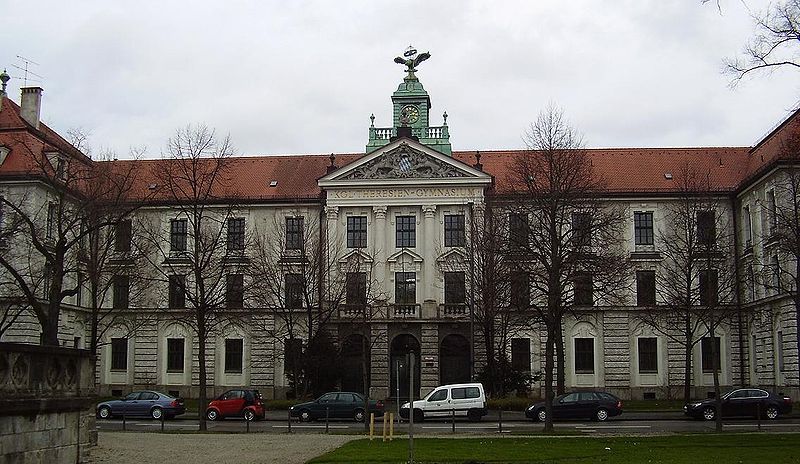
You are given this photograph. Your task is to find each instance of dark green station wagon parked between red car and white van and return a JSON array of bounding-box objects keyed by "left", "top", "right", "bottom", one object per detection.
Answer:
[{"left": 289, "top": 392, "right": 384, "bottom": 422}]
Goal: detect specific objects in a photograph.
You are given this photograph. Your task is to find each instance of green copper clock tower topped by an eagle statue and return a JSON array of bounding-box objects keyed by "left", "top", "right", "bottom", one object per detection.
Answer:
[{"left": 367, "top": 47, "right": 452, "bottom": 155}]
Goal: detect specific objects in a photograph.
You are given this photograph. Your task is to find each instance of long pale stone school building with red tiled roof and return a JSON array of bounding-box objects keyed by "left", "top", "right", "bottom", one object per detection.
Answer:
[{"left": 0, "top": 58, "right": 800, "bottom": 398}]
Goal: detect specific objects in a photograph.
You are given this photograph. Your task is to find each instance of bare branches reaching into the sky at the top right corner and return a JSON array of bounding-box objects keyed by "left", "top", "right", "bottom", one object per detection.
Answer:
[{"left": 717, "top": 0, "right": 800, "bottom": 85}]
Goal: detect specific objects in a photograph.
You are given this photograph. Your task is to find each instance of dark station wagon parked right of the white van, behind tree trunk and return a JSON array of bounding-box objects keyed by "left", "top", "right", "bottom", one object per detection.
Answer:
[{"left": 525, "top": 391, "right": 622, "bottom": 422}]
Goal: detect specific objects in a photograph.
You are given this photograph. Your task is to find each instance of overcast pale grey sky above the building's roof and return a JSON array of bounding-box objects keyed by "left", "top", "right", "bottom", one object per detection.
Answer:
[{"left": 0, "top": 0, "right": 800, "bottom": 157}]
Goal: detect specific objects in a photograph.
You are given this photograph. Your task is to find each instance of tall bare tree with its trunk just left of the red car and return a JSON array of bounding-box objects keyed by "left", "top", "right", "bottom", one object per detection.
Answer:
[{"left": 142, "top": 125, "right": 236, "bottom": 430}]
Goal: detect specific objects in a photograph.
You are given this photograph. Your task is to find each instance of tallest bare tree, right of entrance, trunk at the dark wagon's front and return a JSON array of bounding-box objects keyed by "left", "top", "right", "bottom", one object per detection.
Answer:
[{"left": 507, "top": 105, "right": 626, "bottom": 430}]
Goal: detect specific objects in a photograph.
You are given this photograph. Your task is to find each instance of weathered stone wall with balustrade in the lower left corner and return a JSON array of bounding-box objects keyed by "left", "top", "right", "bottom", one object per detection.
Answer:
[{"left": 0, "top": 343, "right": 97, "bottom": 464}]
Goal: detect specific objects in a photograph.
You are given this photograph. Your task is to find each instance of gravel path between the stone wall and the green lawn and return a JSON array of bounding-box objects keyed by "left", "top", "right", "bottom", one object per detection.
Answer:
[{"left": 90, "top": 432, "right": 361, "bottom": 464}]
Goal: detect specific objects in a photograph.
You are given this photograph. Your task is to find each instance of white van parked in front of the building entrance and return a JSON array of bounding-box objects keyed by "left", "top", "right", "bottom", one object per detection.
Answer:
[{"left": 400, "top": 383, "right": 488, "bottom": 422}]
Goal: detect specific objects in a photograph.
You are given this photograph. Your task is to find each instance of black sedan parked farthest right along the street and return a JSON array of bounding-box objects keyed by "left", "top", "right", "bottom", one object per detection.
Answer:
[{"left": 683, "top": 388, "right": 792, "bottom": 420}]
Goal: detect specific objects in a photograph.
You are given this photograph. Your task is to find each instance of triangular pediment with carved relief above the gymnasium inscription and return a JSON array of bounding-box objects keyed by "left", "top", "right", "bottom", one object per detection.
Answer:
[{"left": 319, "top": 138, "right": 491, "bottom": 187}]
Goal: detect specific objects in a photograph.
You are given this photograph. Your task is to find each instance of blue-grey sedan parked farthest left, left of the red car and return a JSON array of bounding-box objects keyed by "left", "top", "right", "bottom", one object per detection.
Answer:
[{"left": 97, "top": 390, "right": 186, "bottom": 419}]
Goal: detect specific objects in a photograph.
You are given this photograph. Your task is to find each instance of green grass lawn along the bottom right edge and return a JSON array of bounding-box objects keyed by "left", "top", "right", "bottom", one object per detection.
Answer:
[{"left": 309, "top": 434, "right": 800, "bottom": 464}]
